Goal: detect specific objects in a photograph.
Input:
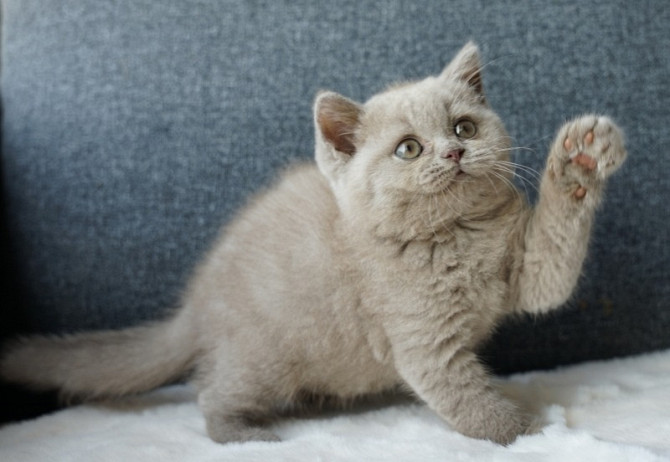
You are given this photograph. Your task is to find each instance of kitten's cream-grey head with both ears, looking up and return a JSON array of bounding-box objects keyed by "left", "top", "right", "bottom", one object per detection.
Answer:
[{"left": 314, "top": 43, "right": 511, "bottom": 239}]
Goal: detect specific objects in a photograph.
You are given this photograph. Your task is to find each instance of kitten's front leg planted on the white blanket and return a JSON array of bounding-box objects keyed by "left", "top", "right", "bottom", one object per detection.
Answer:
[{"left": 389, "top": 318, "right": 532, "bottom": 445}]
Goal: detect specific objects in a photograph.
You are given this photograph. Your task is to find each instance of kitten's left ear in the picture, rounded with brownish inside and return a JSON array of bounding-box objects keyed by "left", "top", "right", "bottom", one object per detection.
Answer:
[{"left": 314, "top": 91, "right": 363, "bottom": 180}]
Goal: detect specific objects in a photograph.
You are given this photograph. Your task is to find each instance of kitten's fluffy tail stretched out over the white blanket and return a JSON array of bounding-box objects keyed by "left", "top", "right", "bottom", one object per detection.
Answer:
[{"left": 0, "top": 310, "right": 197, "bottom": 398}]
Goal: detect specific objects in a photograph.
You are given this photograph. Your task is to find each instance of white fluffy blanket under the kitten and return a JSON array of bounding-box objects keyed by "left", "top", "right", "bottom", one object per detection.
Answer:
[{"left": 0, "top": 351, "right": 670, "bottom": 462}]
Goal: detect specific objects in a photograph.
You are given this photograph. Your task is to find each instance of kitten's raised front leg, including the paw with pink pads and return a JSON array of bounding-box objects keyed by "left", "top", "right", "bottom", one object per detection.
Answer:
[{"left": 517, "top": 115, "right": 626, "bottom": 312}]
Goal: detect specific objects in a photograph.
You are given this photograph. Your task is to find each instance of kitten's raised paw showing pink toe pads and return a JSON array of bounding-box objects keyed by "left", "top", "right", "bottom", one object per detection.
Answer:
[{"left": 550, "top": 115, "right": 626, "bottom": 199}]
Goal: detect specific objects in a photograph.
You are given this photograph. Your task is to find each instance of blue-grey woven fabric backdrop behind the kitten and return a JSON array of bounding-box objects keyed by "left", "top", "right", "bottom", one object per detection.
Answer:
[{"left": 0, "top": 0, "right": 670, "bottom": 372}]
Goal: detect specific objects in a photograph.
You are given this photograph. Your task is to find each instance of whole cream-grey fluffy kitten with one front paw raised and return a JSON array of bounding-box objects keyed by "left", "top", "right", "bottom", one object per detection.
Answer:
[{"left": 0, "top": 42, "right": 626, "bottom": 444}]
